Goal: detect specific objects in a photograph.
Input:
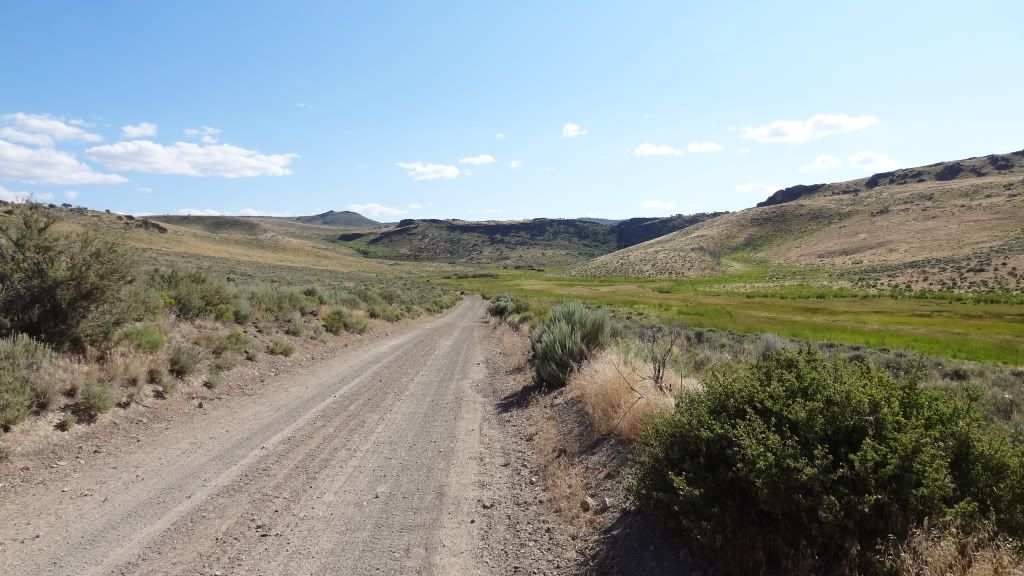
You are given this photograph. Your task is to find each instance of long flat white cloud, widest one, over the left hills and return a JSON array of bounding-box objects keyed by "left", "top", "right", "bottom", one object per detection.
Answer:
[{"left": 86, "top": 140, "right": 299, "bottom": 178}]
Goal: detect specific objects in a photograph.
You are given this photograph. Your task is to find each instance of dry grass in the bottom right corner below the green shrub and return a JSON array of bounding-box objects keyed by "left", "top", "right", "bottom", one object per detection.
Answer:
[{"left": 889, "top": 526, "right": 1024, "bottom": 576}]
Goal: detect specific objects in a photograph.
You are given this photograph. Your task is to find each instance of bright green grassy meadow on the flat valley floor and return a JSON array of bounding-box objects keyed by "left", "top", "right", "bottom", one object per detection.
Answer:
[{"left": 450, "top": 269, "right": 1024, "bottom": 365}]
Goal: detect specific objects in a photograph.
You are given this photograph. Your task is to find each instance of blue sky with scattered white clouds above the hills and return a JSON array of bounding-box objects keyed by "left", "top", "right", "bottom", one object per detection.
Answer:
[{"left": 0, "top": 0, "right": 1024, "bottom": 220}]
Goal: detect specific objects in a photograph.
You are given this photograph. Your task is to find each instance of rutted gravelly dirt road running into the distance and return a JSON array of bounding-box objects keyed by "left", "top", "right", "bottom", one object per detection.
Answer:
[{"left": 0, "top": 298, "right": 489, "bottom": 575}]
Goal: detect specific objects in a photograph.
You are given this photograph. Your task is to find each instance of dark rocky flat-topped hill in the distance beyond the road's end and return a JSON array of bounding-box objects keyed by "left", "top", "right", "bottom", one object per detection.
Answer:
[{"left": 338, "top": 214, "right": 714, "bottom": 268}]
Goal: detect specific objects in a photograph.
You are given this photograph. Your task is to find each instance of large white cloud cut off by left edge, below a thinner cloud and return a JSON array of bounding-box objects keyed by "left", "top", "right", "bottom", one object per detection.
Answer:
[{"left": 0, "top": 140, "right": 128, "bottom": 184}]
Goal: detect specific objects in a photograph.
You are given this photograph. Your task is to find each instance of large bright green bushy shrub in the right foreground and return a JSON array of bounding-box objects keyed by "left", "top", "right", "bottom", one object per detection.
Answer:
[{"left": 631, "top": 349, "right": 1024, "bottom": 574}]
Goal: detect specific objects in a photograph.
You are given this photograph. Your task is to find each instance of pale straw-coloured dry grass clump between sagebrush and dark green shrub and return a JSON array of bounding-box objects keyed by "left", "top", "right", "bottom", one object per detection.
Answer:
[{"left": 568, "top": 348, "right": 683, "bottom": 441}]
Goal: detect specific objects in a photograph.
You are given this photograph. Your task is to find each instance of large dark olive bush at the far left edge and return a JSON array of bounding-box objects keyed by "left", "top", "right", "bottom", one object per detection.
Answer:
[{"left": 0, "top": 203, "right": 135, "bottom": 349}]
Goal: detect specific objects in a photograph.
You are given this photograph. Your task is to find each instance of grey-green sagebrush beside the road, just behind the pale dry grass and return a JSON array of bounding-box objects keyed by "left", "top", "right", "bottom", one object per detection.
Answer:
[{"left": 530, "top": 301, "right": 611, "bottom": 386}]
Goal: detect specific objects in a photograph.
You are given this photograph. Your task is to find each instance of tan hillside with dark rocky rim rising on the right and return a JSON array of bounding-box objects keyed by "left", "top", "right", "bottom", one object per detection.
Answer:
[{"left": 572, "top": 151, "right": 1024, "bottom": 292}]
